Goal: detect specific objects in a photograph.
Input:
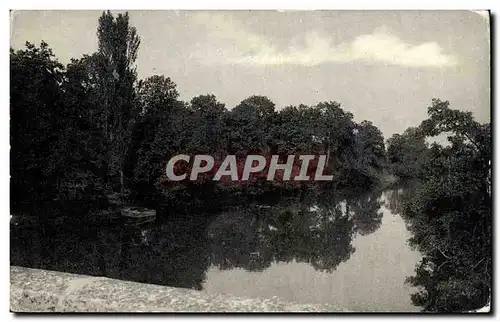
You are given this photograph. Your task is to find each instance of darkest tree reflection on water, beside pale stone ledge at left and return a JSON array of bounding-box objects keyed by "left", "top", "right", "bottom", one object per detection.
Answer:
[{"left": 11, "top": 217, "right": 210, "bottom": 290}]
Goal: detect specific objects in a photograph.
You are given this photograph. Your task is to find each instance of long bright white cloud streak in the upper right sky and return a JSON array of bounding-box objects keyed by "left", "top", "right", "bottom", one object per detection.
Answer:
[{"left": 190, "top": 13, "right": 458, "bottom": 68}]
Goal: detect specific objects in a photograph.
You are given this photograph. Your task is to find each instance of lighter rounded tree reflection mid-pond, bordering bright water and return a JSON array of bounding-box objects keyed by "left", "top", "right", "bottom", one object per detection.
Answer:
[{"left": 208, "top": 191, "right": 382, "bottom": 272}]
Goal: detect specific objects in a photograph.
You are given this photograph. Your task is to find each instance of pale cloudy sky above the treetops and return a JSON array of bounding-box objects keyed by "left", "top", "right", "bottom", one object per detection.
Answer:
[{"left": 11, "top": 10, "right": 490, "bottom": 138}]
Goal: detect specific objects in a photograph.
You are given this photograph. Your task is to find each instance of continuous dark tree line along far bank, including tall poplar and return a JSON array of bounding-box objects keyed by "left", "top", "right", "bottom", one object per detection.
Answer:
[{"left": 10, "top": 12, "right": 385, "bottom": 216}]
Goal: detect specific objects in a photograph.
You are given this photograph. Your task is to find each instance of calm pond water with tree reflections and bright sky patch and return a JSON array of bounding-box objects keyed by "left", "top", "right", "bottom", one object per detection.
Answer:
[{"left": 11, "top": 190, "right": 420, "bottom": 311}]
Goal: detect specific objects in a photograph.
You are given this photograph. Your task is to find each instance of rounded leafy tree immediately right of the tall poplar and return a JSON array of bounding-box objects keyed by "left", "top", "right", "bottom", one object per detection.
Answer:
[{"left": 126, "top": 75, "right": 187, "bottom": 201}]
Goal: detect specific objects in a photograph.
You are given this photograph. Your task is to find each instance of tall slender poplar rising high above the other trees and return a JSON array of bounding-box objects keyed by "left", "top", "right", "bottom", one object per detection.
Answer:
[{"left": 92, "top": 11, "right": 141, "bottom": 200}]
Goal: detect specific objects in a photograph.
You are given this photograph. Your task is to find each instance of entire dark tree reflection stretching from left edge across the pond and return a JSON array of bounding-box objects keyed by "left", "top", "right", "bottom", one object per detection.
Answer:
[{"left": 11, "top": 192, "right": 381, "bottom": 290}]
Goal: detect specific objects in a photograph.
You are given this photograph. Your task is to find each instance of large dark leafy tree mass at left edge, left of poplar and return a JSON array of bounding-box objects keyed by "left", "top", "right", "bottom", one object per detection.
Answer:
[{"left": 11, "top": 42, "right": 110, "bottom": 217}]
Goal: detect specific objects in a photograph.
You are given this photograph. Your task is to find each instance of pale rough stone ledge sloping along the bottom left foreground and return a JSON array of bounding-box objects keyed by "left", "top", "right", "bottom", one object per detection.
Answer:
[{"left": 10, "top": 266, "right": 342, "bottom": 312}]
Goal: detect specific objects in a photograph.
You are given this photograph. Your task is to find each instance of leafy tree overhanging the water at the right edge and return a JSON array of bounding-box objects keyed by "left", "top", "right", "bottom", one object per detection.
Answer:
[{"left": 404, "top": 100, "right": 492, "bottom": 312}]
